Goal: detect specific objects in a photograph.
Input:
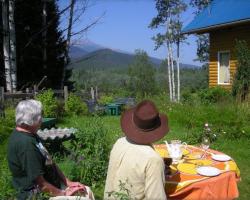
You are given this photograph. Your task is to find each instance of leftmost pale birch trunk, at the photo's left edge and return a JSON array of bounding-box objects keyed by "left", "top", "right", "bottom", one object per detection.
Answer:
[{"left": 2, "top": 0, "right": 12, "bottom": 92}]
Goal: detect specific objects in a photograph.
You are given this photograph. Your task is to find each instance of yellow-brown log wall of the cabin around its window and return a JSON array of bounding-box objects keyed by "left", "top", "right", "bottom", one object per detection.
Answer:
[{"left": 209, "top": 25, "right": 250, "bottom": 89}]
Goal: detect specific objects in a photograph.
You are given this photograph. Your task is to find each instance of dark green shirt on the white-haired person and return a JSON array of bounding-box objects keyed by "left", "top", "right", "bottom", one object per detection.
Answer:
[{"left": 7, "top": 130, "right": 46, "bottom": 199}]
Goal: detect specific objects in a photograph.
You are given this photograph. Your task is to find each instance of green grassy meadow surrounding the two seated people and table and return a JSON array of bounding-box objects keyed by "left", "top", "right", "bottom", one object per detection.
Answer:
[{"left": 0, "top": 94, "right": 250, "bottom": 200}]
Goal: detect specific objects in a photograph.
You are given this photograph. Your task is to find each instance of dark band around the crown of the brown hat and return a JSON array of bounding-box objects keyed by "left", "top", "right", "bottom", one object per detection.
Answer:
[{"left": 132, "top": 114, "right": 161, "bottom": 132}]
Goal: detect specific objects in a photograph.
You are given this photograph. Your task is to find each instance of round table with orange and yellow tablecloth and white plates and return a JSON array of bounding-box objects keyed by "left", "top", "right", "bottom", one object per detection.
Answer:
[{"left": 154, "top": 144, "right": 240, "bottom": 200}]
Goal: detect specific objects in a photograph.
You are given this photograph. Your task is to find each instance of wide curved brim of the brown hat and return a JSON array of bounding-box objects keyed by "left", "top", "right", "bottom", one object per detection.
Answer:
[{"left": 121, "top": 108, "right": 169, "bottom": 144}]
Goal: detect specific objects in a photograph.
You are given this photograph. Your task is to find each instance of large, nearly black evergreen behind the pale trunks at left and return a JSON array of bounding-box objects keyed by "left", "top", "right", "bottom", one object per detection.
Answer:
[{"left": 15, "top": 0, "right": 65, "bottom": 89}]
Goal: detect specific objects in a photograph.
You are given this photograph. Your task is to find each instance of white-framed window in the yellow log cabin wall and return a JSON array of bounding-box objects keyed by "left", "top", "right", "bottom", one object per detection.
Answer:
[{"left": 218, "top": 51, "right": 230, "bottom": 84}]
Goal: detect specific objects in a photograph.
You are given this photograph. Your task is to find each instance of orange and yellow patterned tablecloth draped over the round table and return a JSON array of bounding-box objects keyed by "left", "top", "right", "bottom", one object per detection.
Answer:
[{"left": 154, "top": 144, "right": 240, "bottom": 200}]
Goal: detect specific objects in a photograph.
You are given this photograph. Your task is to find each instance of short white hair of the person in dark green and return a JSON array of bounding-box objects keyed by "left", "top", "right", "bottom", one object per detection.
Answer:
[{"left": 16, "top": 99, "right": 42, "bottom": 126}]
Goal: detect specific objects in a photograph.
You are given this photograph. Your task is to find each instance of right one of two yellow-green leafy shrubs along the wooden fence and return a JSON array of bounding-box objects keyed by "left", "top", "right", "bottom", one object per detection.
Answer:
[{"left": 64, "top": 93, "right": 88, "bottom": 115}]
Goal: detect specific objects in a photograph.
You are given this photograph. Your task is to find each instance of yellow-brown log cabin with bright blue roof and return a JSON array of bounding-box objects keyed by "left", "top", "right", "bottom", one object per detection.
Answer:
[{"left": 182, "top": 0, "right": 250, "bottom": 89}]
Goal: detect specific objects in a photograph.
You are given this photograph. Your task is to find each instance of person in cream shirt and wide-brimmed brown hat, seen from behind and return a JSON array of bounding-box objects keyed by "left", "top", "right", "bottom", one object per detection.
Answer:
[{"left": 104, "top": 100, "right": 169, "bottom": 200}]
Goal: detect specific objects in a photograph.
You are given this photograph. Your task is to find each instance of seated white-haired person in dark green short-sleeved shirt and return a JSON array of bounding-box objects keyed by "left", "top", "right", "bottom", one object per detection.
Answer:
[{"left": 7, "top": 100, "right": 94, "bottom": 200}]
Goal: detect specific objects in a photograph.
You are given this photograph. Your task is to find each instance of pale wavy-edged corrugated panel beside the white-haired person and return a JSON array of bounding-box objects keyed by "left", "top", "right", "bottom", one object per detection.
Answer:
[{"left": 37, "top": 127, "right": 77, "bottom": 140}]
